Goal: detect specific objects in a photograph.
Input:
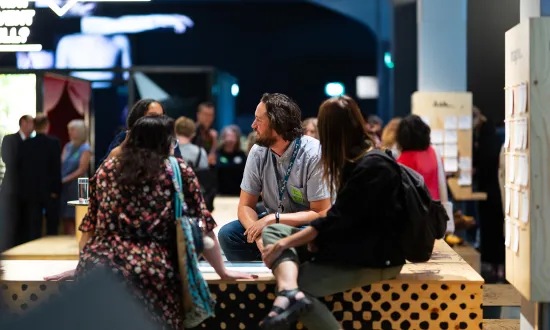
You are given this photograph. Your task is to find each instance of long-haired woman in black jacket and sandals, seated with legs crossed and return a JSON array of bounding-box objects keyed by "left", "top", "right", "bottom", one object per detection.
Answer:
[{"left": 261, "top": 96, "right": 405, "bottom": 330}]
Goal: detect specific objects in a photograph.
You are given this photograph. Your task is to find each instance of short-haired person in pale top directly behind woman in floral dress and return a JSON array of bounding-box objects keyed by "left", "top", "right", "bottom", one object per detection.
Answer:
[{"left": 175, "top": 117, "right": 209, "bottom": 171}]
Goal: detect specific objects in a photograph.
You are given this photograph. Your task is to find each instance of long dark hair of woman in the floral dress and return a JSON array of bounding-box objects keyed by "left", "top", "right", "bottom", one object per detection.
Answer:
[{"left": 117, "top": 116, "right": 175, "bottom": 186}]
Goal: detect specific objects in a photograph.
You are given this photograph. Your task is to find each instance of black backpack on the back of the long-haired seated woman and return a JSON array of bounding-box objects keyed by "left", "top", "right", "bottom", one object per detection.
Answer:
[{"left": 370, "top": 150, "right": 449, "bottom": 262}]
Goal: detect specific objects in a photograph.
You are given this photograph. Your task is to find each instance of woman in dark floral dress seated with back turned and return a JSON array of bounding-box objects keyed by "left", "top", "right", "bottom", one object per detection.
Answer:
[{"left": 49, "top": 116, "right": 252, "bottom": 329}]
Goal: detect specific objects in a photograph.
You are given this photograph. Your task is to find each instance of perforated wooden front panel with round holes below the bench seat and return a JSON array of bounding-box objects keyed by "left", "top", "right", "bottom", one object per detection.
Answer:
[{"left": 0, "top": 281, "right": 483, "bottom": 329}]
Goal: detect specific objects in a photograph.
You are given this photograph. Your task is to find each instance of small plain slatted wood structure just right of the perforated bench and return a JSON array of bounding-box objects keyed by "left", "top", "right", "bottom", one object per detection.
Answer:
[{"left": 483, "top": 284, "right": 521, "bottom": 330}]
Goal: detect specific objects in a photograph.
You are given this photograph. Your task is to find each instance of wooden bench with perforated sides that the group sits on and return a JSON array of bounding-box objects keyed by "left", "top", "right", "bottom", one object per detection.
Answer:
[{"left": 0, "top": 240, "right": 483, "bottom": 330}]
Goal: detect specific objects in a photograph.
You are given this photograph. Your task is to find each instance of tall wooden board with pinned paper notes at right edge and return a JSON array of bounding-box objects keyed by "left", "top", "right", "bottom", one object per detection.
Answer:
[{"left": 505, "top": 18, "right": 550, "bottom": 302}]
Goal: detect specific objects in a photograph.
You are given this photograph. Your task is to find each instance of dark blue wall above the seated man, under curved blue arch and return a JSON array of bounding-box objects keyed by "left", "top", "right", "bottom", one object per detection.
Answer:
[{"left": 127, "top": 3, "right": 376, "bottom": 125}]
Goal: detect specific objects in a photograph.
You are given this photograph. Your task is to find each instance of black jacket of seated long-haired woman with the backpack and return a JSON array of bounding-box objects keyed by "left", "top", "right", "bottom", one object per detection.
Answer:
[{"left": 311, "top": 154, "right": 405, "bottom": 268}]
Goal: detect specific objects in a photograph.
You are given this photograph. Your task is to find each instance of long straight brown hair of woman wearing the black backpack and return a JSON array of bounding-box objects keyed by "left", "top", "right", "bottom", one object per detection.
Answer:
[{"left": 317, "top": 95, "right": 375, "bottom": 193}]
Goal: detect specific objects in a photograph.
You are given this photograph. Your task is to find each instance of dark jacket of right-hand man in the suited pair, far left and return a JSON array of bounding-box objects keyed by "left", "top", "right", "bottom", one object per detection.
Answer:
[{"left": 18, "top": 134, "right": 61, "bottom": 202}]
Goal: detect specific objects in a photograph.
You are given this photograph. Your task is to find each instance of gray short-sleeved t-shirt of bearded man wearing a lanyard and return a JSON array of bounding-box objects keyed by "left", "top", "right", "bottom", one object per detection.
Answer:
[{"left": 241, "top": 136, "right": 330, "bottom": 213}]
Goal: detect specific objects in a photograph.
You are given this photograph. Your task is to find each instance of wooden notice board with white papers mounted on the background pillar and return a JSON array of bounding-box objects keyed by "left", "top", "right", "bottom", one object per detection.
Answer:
[{"left": 412, "top": 92, "right": 473, "bottom": 186}]
